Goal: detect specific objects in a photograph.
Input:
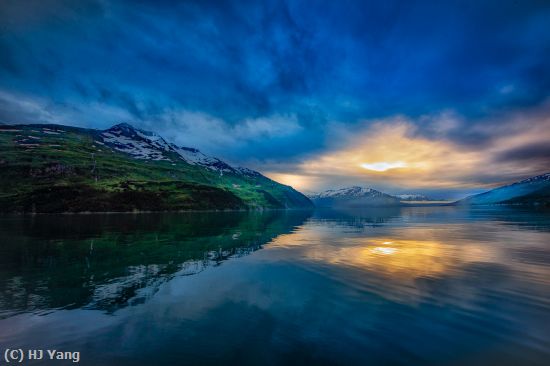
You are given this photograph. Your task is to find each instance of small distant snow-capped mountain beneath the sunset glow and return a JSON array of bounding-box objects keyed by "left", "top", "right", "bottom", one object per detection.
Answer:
[{"left": 309, "top": 186, "right": 400, "bottom": 207}]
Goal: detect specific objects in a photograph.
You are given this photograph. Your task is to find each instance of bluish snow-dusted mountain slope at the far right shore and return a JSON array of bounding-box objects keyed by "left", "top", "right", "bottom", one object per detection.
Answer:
[{"left": 456, "top": 173, "right": 550, "bottom": 206}]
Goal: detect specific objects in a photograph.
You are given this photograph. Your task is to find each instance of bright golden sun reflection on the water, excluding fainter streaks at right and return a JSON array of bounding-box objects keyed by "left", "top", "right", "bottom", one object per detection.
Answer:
[{"left": 270, "top": 227, "right": 503, "bottom": 281}]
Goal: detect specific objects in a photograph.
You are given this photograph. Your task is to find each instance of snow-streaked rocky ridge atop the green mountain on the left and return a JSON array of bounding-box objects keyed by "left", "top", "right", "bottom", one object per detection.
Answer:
[{"left": 96, "top": 123, "right": 252, "bottom": 176}]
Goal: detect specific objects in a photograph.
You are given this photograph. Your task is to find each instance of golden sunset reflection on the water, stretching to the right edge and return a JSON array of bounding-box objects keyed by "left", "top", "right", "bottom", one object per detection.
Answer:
[{"left": 267, "top": 223, "right": 550, "bottom": 290}]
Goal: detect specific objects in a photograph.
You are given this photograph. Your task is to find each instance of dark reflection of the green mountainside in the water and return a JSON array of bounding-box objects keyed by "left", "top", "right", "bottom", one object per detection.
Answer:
[{"left": 0, "top": 211, "right": 310, "bottom": 318}]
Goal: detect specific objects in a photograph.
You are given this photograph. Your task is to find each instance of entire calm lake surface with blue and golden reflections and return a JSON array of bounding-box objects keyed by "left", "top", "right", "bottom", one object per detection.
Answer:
[{"left": 0, "top": 207, "right": 550, "bottom": 365}]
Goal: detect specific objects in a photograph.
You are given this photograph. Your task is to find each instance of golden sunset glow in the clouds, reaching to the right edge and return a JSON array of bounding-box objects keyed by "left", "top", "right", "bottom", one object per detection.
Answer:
[{"left": 268, "top": 114, "right": 550, "bottom": 191}]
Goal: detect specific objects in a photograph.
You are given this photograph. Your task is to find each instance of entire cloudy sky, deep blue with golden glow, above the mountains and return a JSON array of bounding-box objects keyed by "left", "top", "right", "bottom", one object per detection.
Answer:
[{"left": 0, "top": 0, "right": 550, "bottom": 198}]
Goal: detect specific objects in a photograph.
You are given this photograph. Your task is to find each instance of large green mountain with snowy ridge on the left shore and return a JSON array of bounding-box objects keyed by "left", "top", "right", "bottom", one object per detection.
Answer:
[{"left": 0, "top": 123, "right": 313, "bottom": 212}]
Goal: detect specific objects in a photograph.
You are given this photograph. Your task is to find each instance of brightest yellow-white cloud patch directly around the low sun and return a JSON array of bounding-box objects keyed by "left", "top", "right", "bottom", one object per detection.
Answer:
[{"left": 294, "top": 117, "right": 488, "bottom": 188}]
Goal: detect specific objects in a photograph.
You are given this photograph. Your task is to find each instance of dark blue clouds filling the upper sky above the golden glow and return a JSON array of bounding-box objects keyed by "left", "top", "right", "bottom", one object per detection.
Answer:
[{"left": 0, "top": 0, "right": 550, "bottom": 167}]
